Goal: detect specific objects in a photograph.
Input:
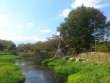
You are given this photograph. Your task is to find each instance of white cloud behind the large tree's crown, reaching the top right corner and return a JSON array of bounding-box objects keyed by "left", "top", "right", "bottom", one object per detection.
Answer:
[{"left": 60, "top": 0, "right": 110, "bottom": 17}]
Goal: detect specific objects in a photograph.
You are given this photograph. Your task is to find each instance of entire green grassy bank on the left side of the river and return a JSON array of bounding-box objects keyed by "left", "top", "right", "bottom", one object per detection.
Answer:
[{"left": 0, "top": 55, "right": 24, "bottom": 83}]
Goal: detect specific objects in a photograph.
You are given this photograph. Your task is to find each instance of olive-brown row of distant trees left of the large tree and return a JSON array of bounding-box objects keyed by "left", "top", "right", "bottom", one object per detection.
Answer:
[{"left": 17, "top": 36, "right": 59, "bottom": 64}]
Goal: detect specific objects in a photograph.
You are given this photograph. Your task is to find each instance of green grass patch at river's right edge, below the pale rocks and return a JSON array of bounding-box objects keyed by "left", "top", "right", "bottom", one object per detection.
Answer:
[{"left": 42, "top": 59, "right": 79, "bottom": 76}]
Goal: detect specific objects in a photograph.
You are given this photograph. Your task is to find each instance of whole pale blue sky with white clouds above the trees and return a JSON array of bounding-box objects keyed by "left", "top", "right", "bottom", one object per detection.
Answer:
[{"left": 0, "top": 0, "right": 110, "bottom": 44}]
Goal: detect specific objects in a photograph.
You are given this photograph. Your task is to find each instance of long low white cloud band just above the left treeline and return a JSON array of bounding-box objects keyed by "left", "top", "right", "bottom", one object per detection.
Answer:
[{"left": 0, "top": 33, "right": 46, "bottom": 43}]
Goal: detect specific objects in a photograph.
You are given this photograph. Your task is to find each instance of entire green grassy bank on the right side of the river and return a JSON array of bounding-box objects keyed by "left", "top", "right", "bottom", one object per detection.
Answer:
[{"left": 42, "top": 54, "right": 110, "bottom": 83}]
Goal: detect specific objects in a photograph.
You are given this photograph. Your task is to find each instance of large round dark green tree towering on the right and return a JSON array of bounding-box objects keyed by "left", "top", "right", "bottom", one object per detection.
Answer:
[{"left": 58, "top": 6, "right": 106, "bottom": 54}]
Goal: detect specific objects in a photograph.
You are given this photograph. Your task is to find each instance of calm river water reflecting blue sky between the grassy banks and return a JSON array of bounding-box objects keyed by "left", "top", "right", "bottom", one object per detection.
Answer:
[{"left": 17, "top": 59, "right": 59, "bottom": 83}]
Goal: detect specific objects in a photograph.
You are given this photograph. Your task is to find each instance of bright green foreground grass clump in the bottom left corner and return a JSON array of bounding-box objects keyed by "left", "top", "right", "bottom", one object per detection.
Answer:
[{"left": 0, "top": 64, "right": 24, "bottom": 83}]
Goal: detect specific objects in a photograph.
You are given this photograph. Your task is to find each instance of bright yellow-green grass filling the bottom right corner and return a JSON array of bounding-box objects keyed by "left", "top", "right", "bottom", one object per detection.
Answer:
[{"left": 67, "top": 64, "right": 110, "bottom": 83}]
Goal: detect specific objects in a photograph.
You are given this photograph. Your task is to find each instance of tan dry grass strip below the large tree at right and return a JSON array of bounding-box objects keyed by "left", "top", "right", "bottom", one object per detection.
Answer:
[{"left": 79, "top": 52, "right": 110, "bottom": 63}]
